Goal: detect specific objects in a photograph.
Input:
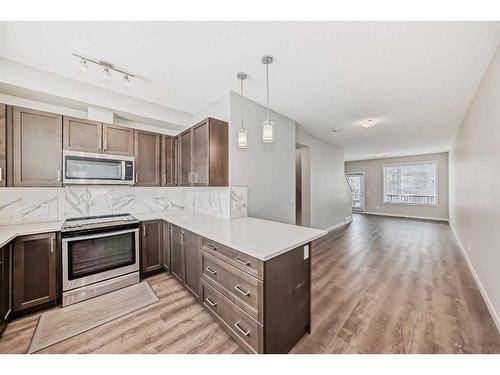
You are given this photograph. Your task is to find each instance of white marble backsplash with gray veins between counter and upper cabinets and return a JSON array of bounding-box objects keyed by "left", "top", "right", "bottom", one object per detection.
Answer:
[{"left": 0, "top": 186, "right": 247, "bottom": 225}]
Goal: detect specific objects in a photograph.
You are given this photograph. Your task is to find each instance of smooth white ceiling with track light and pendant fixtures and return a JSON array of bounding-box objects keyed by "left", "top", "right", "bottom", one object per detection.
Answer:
[{"left": 0, "top": 22, "right": 500, "bottom": 160}]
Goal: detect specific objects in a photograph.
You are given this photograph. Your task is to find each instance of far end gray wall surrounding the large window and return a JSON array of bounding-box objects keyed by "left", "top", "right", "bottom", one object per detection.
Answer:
[{"left": 346, "top": 152, "right": 448, "bottom": 220}]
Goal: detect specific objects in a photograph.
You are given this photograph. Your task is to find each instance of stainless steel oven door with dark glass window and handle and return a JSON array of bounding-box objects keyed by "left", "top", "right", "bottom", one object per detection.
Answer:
[{"left": 62, "top": 228, "right": 139, "bottom": 291}]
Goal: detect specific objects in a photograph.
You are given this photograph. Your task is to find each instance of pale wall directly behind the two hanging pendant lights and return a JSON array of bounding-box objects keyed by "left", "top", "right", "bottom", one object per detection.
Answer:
[{"left": 229, "top": 92, "right": 295, "bottom": 224}]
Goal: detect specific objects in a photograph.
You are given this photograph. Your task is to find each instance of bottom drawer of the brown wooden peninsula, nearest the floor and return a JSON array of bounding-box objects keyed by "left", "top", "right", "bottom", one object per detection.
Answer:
[{"left": 201, "top": 280, "right": 264, "bottom": 353}]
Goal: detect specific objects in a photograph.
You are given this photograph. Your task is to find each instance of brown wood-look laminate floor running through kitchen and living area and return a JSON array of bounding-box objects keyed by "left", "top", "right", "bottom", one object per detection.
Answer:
[{"left": 0, "top": 215, "right": 500, "bottom": 353}]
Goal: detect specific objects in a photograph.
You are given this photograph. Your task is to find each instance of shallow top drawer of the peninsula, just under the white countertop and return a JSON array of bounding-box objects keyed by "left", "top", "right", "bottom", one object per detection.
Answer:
[{"left": 202, "top": 238, "right": 264, "bottom": 280}]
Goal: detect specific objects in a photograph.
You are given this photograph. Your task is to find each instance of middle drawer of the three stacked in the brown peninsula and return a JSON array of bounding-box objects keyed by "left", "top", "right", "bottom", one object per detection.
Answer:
[{"left": 201, "top": 251, "right": 264, "bottom": 323}]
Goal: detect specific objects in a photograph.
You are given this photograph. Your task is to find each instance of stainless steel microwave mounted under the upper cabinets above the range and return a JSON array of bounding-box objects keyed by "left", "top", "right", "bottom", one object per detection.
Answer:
[{"left": 63, "top": 150, "right": 135, "bottom": 185}]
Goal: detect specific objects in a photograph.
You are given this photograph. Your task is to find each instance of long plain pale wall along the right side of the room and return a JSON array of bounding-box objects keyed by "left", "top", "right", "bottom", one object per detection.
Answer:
[{"left": 450, "top": 47, "right": 500, "bottom": 331}]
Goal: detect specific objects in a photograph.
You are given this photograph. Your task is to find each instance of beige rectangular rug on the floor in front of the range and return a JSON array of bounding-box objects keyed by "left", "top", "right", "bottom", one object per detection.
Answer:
[{"left": 28, "top": 281, "right": 159, "bottom": 353}]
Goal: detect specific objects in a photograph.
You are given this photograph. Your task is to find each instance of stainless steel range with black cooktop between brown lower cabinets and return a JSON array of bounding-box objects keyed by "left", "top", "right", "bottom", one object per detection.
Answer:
[{"left": 61, "top": 214, "right": 139, "bottom": 306}]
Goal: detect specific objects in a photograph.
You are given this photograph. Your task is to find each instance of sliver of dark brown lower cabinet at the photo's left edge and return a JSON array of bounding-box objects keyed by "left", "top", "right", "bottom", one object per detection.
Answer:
[{"left": 0, "top": 244, "right": 12, "bottom": 335}]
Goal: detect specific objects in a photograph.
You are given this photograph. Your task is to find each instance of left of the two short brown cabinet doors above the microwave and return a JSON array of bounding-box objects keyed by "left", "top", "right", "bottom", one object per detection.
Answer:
[{"left": 63, "top": 116, "right": 102, "bottom": 153}]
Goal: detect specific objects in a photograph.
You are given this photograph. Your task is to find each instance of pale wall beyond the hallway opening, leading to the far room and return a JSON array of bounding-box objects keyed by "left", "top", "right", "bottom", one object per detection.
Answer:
[{"left": 296, "top": 127, "right": 351, "bottom": 229}]
